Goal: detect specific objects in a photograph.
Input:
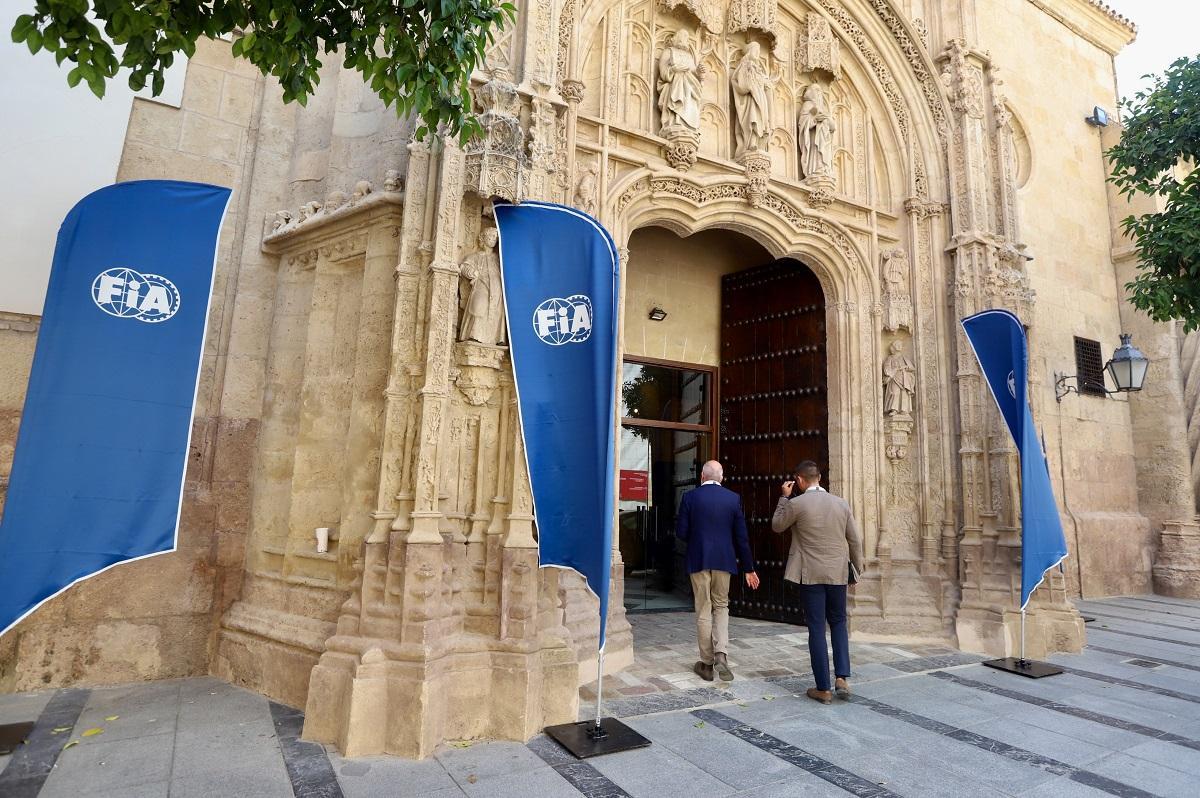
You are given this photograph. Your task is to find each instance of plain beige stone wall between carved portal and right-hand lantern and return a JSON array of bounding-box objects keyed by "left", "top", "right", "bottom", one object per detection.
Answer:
[{"left": 978, "top": 0, "right": 1154, "bottom": 598}]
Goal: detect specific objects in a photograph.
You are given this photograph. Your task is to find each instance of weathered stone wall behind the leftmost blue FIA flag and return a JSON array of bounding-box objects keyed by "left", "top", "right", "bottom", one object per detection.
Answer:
[{"left": 0, "top": 41, "right": 260, "bottom": 691}]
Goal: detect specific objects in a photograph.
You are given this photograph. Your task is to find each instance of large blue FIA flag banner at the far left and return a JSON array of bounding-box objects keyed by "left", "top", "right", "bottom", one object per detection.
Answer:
[{"left": 0, "top": 180, "right": 230, "bottom": 634}]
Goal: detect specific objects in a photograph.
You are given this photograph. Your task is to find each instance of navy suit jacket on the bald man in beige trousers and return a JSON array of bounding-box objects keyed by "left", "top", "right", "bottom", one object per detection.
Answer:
[{"left": 676, "top": 485, "right": 755, "bottom": 574}]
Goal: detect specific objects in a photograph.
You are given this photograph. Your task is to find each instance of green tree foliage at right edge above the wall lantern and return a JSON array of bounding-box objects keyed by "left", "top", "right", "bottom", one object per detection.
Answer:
[{"left": 1106, "top": 55, "right": 1200, "bottom": 331}]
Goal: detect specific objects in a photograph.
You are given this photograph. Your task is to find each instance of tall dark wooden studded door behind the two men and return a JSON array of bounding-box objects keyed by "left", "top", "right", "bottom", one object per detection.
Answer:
[{"left": 718, "top": 259, "right": 829, "bottom": 623}]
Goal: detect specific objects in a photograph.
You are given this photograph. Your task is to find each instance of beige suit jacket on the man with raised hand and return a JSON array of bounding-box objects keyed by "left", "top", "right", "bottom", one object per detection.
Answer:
[{"left": 770, "top": 490, "right": 863, "bottom": 584}]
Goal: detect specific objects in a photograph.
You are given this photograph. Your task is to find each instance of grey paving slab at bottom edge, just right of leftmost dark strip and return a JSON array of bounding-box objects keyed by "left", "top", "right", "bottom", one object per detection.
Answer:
[{"left": 41, "top": 734, "right": 175, "bottom": 798}]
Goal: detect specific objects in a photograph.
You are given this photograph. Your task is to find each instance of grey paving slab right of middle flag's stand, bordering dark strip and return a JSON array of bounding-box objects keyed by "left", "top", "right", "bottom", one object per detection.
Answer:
[{"left": 630, "top": 713, "right": 796, "bottom": 790}]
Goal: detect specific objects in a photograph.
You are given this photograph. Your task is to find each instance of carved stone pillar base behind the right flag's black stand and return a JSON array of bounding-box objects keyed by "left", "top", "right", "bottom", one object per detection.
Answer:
[{"left": 955, "top": 605, "right": 1087, "bottom": 659}]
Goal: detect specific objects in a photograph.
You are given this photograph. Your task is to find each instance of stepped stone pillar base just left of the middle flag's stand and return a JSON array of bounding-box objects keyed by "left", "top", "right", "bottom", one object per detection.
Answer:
[{"left": 304, "top": 637, "right": 580, "bottom": 760}]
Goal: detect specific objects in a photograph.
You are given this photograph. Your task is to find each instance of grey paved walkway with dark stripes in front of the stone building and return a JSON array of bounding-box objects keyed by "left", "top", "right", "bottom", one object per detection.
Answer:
[{"left": 0, "top": 596, "right": 1200, "bottom": 798}]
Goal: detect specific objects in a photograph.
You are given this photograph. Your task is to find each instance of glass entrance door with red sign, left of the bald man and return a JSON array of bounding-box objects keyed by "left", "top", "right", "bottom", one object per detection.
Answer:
[{"left": 618, "top": 360, "right": 713, "bottom": 612}]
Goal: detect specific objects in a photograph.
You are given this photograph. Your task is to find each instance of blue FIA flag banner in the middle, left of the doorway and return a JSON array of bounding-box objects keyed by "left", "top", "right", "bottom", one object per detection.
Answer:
[{"left": 496, "top": 202, "right": 620, "bottom": 650}]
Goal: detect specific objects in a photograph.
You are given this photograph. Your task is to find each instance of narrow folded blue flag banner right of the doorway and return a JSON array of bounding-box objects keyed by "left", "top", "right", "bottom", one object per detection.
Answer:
[{"left": 962, "top": 310, "right": 1067, "bottom": 610}]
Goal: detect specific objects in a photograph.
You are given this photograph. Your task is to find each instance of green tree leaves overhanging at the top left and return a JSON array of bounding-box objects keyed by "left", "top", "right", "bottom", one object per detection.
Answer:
[{"left": 12, "top": 0, "right": 516, "bottom": 142}]
